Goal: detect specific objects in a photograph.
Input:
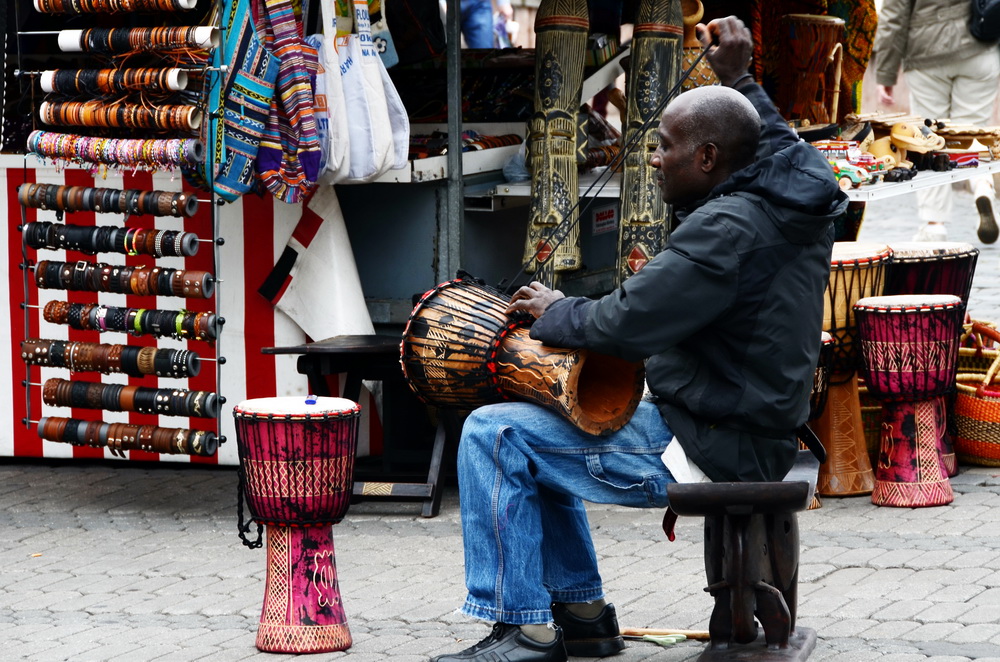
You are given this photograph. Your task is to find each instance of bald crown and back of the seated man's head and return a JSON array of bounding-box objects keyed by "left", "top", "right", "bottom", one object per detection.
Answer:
[{"left": 663, "top": 85, "right": 760, "bottom": 176}]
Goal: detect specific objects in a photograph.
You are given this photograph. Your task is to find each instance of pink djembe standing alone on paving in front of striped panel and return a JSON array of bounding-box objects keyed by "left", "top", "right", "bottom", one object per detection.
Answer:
[{"left": 233, "top": 396, "right": 361, "bottom": 653}]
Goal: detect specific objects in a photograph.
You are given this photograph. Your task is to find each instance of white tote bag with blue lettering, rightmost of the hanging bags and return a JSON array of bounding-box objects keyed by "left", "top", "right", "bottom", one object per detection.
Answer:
[{"left": 337, "top": 0, "right": 395, "bottom": 184}]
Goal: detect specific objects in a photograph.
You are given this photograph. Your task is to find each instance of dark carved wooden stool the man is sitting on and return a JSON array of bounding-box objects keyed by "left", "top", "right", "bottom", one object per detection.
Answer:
[{"left": 667, "top": 451, "right": 819, "bottom": 662}]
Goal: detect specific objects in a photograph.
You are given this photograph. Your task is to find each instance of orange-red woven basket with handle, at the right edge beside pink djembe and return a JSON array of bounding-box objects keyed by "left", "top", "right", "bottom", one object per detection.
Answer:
[{"left": 955, "top": 323, "right": 1000, "bottom": 467}]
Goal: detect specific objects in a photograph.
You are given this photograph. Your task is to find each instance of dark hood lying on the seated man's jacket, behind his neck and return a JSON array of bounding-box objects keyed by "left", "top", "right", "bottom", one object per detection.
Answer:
[{"left": 689, "top": 142, "right": 848, "bottom": 244}]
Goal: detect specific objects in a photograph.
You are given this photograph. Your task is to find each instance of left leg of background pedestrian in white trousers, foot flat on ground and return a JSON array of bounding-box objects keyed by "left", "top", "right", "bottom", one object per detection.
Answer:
[{"left": 905, "top": 66, "right": 954, "bottom": 241}]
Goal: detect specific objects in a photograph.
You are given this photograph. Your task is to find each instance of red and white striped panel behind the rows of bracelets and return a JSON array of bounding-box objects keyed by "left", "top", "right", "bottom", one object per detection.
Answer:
[{"left": 0, "top": 165, "right": 381, "bottom": 465}]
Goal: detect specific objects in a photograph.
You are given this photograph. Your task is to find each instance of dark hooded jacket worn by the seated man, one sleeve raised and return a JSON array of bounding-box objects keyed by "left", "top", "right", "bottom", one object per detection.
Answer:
[{"left": 531, "top": 85, "right": 847, "bottom": 481}]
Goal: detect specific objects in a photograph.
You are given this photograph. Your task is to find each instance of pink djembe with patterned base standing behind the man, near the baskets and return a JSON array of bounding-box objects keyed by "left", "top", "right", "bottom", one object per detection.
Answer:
[{"left": 854, "top": 294, "right": 965, "bottom": 508}]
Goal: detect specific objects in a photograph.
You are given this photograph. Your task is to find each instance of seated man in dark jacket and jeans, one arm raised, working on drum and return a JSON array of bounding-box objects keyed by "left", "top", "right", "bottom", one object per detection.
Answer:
[{"left": 436, "top": 17, "right": 847, "bottom": 662}]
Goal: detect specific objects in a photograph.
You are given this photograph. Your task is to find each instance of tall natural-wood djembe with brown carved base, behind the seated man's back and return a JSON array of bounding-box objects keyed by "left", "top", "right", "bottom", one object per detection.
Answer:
[{"left": 814, "top": 241, "right": 892, "bottom": 496}]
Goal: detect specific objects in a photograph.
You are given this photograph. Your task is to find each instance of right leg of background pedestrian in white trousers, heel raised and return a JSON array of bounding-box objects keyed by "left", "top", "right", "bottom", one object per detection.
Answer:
[{"left": 951, "top": 49, "right": 1000, "bottom": 244}]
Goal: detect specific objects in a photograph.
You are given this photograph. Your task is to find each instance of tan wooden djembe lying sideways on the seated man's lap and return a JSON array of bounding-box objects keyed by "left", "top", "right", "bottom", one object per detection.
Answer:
[{"left": 400, "top": 279, "right": 645, "bottom": 434}]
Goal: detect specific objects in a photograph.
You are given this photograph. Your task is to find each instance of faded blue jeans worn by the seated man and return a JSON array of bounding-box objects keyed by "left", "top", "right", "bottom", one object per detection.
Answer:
[{"left": 458, "top": 402, "right": 674, "bottom": 625}]
